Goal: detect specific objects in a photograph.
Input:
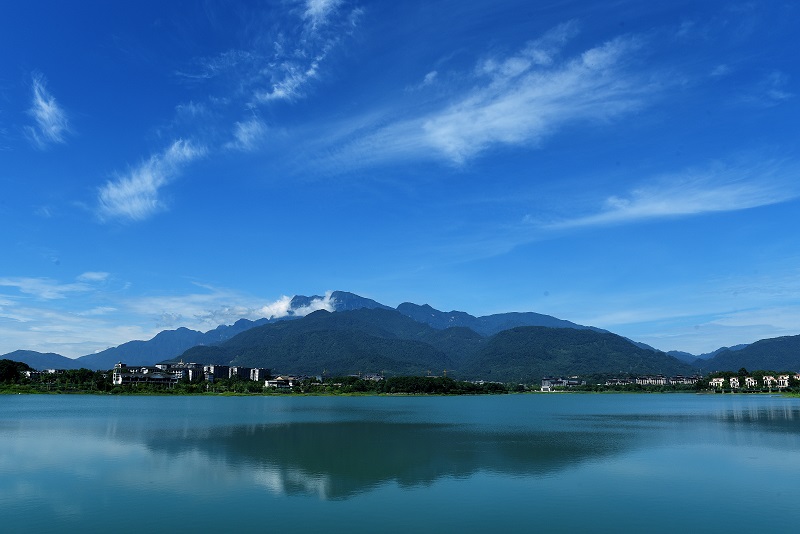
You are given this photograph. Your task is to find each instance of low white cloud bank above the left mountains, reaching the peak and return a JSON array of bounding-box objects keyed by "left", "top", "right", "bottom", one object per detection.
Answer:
[{"left": 0, "top": 271, "right": 334, "bottom": 357}]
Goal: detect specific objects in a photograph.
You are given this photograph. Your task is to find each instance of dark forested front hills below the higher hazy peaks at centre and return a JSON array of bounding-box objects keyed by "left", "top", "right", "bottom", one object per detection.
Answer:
[{"left": 177, "top": 308, "right": 693, "bottom": 382}]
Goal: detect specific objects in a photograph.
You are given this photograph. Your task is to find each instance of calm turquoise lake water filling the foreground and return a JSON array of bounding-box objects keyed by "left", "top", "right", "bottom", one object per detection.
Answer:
[{"left": 0, "top": 394, "right": 800, "bottom": 532}]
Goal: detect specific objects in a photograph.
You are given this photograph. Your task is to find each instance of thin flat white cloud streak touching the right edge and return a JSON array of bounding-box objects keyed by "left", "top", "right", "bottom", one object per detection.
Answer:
[{"left": 548, "top": 157, "right": 800, "bottom": 229}]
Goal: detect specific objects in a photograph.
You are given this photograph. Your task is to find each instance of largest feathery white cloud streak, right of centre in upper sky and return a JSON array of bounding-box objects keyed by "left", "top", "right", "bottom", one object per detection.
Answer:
[{"left": 324, "top": 23, "right": 662, "bottom": 168}]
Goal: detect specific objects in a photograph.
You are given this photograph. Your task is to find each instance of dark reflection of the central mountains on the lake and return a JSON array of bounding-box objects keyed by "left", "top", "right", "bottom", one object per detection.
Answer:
[{"left": 146, "top": 421, "right": 632, "bottom": 499}]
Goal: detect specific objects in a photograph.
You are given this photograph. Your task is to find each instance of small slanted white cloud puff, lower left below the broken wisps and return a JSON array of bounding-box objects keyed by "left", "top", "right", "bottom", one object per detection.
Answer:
[{"left": 98, "top": 140, "right": 206, "bottom": 221}]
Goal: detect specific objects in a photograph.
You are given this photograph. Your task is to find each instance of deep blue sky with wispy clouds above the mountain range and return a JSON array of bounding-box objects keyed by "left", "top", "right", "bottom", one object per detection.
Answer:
[{"left": 0, "top": 0, "right": 800, "bottom": 357}]
